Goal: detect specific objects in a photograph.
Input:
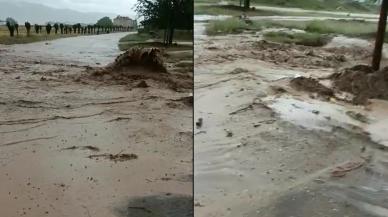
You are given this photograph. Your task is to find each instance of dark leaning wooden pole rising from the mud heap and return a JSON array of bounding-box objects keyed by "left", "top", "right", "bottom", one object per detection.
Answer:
[{"left": 372, "top": 0, "right": 388, "bottom": 71}]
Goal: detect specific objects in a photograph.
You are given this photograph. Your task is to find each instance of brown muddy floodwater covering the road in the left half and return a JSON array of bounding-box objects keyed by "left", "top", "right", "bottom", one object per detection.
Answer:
[{"left": 0, "top": 33, "right": 192, "bottom": 217}]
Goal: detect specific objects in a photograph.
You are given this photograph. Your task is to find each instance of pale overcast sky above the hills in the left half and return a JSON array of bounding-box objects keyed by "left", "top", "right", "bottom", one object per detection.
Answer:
[{"left": 11, "top": 0, "right": 136, "bottom": 17}]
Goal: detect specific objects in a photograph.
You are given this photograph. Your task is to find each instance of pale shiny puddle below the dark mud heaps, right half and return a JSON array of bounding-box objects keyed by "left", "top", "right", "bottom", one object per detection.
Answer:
[{"left": 266, "top": 97, "right": 388, "bottom": 146}]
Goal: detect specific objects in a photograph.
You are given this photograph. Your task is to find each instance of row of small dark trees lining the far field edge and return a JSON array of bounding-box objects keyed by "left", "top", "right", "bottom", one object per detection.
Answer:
[{"left": 6, "top": 17, "right": 130, "bottom": 37}]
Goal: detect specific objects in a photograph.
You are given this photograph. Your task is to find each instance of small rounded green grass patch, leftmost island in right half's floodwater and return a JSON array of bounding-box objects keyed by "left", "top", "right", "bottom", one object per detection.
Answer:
[{"left": 206, "top": 18, "right": 248, "bottom": 35}]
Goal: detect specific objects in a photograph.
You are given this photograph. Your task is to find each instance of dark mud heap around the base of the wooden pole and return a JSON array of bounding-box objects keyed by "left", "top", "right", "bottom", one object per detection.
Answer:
[{"left": 330, "top": 65, "right": 388, "bottom": 104}]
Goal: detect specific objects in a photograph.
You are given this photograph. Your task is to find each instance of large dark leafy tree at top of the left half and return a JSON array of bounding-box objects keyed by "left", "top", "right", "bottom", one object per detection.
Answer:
[{"left": 135, "top": 0, "right": 194, "bottom": 45}]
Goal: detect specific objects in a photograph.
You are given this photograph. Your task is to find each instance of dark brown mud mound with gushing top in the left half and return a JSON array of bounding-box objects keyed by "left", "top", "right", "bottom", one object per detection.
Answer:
[{"left": 79, "top": 47, "right": 192, "bottom": 91}]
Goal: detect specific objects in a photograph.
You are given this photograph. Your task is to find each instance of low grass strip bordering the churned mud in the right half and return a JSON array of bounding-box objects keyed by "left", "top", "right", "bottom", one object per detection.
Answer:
[{"left": 264, "top": 31, "right": 330, "bottom": 47}]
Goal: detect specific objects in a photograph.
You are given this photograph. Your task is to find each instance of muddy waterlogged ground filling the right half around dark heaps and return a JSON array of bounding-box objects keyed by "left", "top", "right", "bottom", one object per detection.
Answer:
[{"left": 194, "top": 11, "right": 388, "bottom": 217}]
